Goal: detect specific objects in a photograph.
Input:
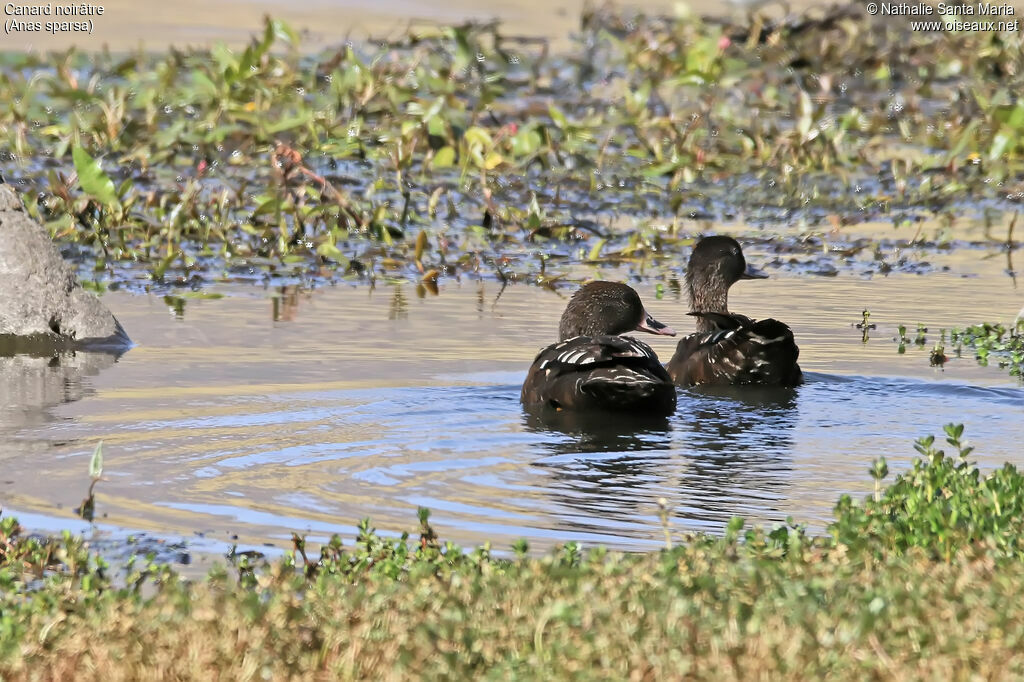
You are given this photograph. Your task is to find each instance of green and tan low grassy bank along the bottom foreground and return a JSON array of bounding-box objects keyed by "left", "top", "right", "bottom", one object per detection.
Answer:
[{"left": 0, "top": 426, "right": 1024, "bottom": 680}]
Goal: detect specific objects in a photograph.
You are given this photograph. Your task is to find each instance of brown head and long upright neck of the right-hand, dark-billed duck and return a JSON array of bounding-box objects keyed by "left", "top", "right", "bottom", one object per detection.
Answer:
[{"left": 686, "top": 236, "right": 768, "bottom": 321}]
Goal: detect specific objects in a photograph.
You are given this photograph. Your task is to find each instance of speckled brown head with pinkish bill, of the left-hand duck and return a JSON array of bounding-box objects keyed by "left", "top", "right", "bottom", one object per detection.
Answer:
[{"left": 558, "top": 282, "right": 676, "bottom": 341}]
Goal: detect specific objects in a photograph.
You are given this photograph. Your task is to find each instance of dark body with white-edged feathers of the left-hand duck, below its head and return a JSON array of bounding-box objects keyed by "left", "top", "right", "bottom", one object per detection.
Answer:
[{"left": 520, "top": 336, "right": 676, "bottom": 415}]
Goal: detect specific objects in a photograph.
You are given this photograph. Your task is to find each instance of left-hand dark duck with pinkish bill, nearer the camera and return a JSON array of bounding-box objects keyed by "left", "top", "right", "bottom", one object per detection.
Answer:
[{"left": 520, "top": 282, "right": 676, "bottom": 417}]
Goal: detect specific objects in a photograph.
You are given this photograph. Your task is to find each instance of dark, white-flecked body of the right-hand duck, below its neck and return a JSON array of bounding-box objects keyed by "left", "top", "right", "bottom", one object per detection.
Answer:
[{"left": 668, "top": 312, "right": 803, "bottom": 386}]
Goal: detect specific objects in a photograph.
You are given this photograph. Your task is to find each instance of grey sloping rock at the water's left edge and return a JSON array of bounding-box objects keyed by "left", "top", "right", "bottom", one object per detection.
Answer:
[{"left": 0, "top": 184, "right": 131, "bottom": 354}]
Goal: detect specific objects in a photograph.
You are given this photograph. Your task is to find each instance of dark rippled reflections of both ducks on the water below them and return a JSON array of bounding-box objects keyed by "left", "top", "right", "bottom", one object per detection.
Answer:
[{"left": 525, "top": 387, "right": 800, "bottom": 535}]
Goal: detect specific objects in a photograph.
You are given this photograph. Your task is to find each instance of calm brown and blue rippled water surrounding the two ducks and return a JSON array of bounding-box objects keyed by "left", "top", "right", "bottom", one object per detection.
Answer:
[{"left": 0, "top": 246, "right": 1024, "bottom": 549}]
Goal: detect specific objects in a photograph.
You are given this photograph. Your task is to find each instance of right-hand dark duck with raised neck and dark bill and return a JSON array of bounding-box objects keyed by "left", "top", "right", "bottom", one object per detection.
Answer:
[{"left": 666, "top": 236, "right": 804, "bottom": 386}]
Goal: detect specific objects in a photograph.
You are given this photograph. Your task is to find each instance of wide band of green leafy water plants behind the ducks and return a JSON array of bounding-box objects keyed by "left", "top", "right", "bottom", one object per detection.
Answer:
[{"left": 0, "top": 5, "right": 1024, "bottom": 293}]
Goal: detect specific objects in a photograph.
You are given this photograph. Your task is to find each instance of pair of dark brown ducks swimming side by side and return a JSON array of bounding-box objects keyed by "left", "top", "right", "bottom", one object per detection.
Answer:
[{"left": 521, "top": 237, "right": 803, "bottom": 416}]
